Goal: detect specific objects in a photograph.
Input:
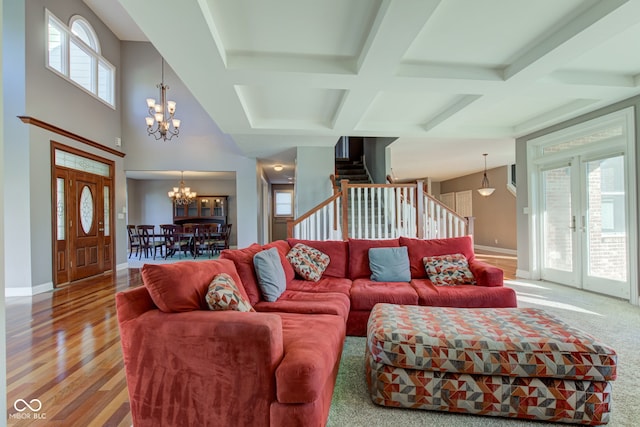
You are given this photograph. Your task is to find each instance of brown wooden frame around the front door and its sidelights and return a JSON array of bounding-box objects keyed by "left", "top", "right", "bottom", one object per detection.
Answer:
[{"left": 50, "top": 140, "right": 116, "bottom": 288}]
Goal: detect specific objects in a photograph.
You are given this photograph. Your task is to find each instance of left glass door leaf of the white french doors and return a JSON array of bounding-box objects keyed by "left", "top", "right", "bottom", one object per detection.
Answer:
[{"left": 540, "top": 165, "right": 578, "bottom": 286}]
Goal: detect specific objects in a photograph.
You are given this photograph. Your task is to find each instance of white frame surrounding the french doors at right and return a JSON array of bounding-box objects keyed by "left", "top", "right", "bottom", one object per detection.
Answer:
[{"left": 527, "top": 107, "right": 640, "bottom": 305}]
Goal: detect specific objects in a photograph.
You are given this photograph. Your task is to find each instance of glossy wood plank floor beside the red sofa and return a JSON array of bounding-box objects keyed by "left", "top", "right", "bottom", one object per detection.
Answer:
[{"left": 6, "top": 254, "right": 516, "bottom": 427}]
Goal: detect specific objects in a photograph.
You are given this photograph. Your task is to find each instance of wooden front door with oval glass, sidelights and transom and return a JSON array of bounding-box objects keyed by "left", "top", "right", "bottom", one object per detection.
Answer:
[{"left": 51, "top": 142, "right": 114, "bottom": 286}]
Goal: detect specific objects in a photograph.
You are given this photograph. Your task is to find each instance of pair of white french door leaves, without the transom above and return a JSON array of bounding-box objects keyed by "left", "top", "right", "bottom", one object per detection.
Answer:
[{"left": 540, "top": 154, "right": 630, "bottom": 299}]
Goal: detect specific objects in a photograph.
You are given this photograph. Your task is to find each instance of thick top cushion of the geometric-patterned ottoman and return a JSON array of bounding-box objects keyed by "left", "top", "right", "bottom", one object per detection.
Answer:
[{"left": 367, "top": 304, "right": 617, "bottom": 381}]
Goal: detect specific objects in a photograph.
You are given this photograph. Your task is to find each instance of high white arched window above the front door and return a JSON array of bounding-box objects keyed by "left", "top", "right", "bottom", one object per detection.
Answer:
[{"left": 46, "top": 10, "right": 116, "bottom": 107}]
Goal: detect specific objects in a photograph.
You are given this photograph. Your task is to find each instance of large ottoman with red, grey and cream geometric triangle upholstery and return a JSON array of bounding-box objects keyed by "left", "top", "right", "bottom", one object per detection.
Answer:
[{"left": 365, "top": 304, "right": 617, "bottom": 425}]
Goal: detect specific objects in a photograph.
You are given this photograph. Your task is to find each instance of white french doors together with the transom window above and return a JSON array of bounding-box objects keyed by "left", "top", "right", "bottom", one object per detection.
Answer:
[{"left": 530, "top": 107, "right": 636, "bottom": 299}]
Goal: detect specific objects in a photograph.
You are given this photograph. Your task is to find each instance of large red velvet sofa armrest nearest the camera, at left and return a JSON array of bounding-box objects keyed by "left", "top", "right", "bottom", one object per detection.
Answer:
[{"left": 120, "top": 310, "right": 284, "bottom": 426}]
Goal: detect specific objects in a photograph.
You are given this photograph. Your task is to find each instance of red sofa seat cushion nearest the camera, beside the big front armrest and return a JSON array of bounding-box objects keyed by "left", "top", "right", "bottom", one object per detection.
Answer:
[{"left": 276, "top": 313, "right": 345, "bottom": 403}]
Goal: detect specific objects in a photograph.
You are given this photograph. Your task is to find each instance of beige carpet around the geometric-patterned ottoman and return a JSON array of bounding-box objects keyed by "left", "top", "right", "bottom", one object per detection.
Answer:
[{"left": 327, "top": 281, "right": 640, "bottom": 427}]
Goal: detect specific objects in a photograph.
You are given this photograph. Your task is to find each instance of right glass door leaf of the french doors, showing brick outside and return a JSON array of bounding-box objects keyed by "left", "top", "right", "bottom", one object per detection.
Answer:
[{"left": 583, "top": 155, "right": 629, "bottom": 298}]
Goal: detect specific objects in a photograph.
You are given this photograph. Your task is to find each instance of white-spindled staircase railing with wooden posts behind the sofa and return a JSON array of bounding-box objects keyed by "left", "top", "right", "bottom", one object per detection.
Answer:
[{"left": 287, "top": 179, "right": 473, "bottom": 240}]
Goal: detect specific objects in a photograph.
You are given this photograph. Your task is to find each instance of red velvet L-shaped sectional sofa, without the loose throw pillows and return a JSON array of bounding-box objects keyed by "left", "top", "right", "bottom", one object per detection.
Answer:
[{"left": 116, "top": 237, "right": 516, "bottom": 427}]
